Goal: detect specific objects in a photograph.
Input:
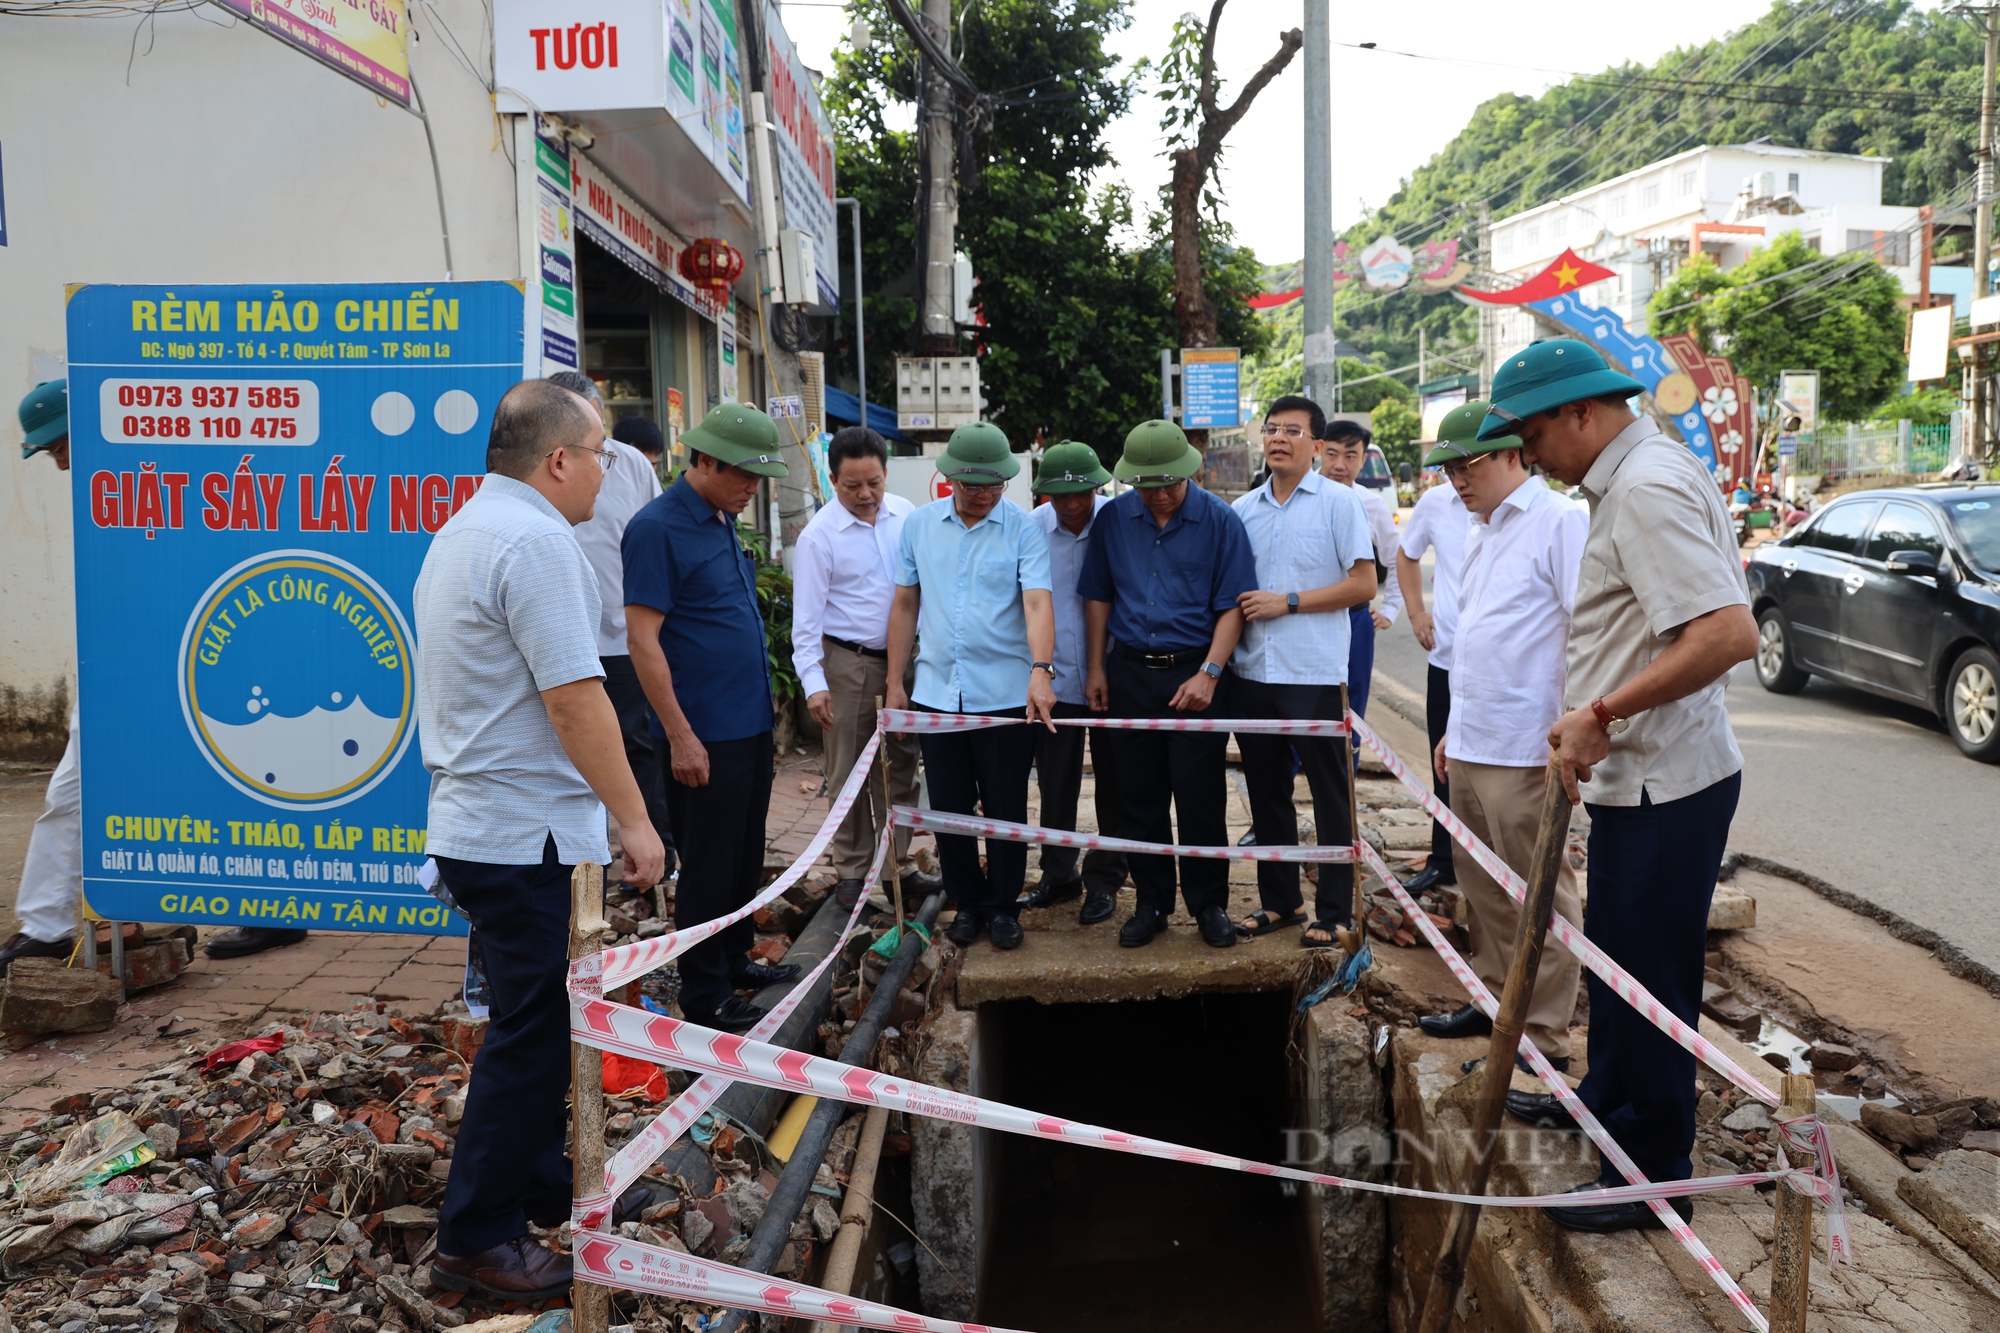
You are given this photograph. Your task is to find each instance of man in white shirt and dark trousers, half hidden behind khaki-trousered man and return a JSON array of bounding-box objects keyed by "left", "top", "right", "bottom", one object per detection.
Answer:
[{"left": 1396, "top": 412, "right": 1486, "bottom": 897}]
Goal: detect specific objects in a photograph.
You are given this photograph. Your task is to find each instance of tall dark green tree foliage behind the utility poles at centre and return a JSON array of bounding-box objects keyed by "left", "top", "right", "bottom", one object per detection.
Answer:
[{"left": 822, "top": 0, "right": 1266, "bottom": 460}]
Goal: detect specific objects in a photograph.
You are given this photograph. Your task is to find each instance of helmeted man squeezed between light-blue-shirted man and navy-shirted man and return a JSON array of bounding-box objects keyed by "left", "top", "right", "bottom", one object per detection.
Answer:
[{"left": 1020, "top": 440, "right": 1126, "bottom": 925}]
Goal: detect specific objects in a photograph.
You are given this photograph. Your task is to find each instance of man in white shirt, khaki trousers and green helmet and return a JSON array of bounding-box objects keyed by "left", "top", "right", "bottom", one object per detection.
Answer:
[{"left": 1420, "top": 404, "right": 1590, "bottom": 1069}]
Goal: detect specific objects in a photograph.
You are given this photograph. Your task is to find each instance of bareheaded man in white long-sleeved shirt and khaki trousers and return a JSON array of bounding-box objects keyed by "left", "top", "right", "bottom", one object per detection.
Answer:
[{"left": 792, "top": 426, "right": 936, "bottom": 907}]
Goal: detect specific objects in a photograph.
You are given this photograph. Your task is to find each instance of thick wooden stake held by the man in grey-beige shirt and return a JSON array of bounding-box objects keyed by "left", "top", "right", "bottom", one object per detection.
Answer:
[{"left": 1418, "top": 755, "right": 1570, "bottom": 1333}]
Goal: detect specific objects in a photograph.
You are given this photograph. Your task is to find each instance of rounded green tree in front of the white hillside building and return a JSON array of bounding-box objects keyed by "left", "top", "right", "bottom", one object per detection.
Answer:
[{"left": 1652, "top": 232, "right": 1904, "bottom": 420}]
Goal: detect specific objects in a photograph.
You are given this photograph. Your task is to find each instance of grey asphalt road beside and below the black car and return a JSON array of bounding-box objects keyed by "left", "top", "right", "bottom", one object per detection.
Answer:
[{"left": 1370, "top": 548, "right": 2000, "bottom": 973}]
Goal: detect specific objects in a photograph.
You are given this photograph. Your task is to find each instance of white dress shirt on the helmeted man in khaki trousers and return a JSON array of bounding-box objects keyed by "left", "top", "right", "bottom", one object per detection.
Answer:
[{"left": 1444, "top": 476, "right": 1590, "bottom": 769}]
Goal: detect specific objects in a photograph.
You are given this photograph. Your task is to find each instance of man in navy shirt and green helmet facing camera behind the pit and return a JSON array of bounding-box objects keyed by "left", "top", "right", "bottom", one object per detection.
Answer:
[{"left": 1076, "top": 420, "right": 1256, "bottom": 949}]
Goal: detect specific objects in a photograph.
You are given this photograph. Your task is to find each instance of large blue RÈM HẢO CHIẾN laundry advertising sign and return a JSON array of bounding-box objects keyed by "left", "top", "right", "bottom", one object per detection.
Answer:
[{"left": 68, "top": 282, "right": 524, "bottom": 935}]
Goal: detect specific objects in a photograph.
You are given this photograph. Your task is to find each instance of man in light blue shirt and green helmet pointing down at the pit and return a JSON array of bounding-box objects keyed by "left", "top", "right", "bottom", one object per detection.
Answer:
[{"left": 888, "top": 422, "right": 1056, "bottom": 949}]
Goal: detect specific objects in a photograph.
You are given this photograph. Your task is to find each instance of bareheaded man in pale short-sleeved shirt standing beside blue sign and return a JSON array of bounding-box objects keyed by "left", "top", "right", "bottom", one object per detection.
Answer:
[{"left": 416, "top": 380, "right": 666, "bottom": 1301}]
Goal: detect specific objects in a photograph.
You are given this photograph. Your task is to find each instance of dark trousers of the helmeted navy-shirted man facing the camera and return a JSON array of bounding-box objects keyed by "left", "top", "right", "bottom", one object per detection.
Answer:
[{"left": 1104, "top": 646, "right": 1238, "bottom": 917}]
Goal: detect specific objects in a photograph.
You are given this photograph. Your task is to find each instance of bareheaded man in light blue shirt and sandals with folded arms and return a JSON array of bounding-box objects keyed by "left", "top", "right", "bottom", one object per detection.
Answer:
[{"left": 1230, "top": 396, "right": 1376, "bottom": 949}]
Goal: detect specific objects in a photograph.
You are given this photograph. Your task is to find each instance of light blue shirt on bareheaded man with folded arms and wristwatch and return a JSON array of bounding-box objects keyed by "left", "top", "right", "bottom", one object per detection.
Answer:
[{"left": 1230, "top": 470, "right": 1374, "bottom": 685}]
